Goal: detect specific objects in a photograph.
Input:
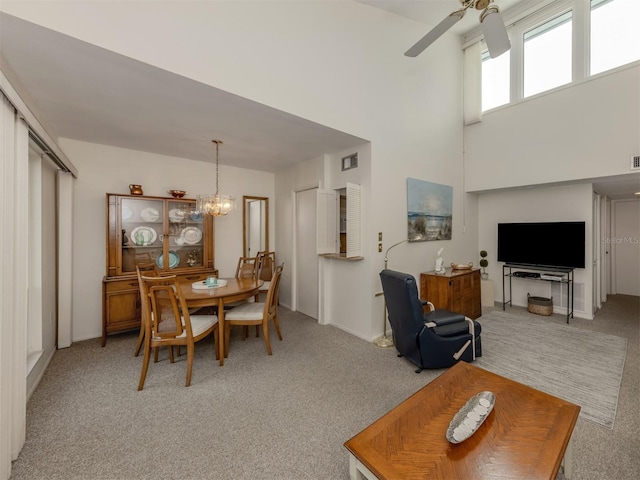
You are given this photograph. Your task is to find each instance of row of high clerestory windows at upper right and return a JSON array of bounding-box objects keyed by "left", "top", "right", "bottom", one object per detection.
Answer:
[{"left": 480, "top": 0, "right": 640, "bottom": 112}]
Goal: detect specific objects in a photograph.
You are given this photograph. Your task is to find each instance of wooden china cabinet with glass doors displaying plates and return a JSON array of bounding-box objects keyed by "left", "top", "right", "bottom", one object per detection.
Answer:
[{"left": 102, "top": 193, "right": 217, "bottom": 346}]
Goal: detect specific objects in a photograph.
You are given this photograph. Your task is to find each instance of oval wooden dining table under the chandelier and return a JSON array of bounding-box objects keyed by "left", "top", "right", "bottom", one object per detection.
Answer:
[{"left": 179, "top": 278, "right": 264, "bottom": 366}]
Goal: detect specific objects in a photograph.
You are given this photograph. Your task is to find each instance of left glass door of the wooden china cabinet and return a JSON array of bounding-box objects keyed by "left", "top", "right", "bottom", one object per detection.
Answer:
[{"left": 118, "top": 198, "right": 164, "bottom": 275}]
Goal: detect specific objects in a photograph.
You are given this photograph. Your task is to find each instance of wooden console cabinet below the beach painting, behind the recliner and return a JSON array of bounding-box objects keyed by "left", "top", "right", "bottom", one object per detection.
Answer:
[{"left": 420, "top": 268, "right": 482, "bottom": 320}]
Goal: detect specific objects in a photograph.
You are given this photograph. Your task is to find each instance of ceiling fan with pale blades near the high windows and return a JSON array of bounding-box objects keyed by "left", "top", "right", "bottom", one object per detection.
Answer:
[{"left": 404, "top": 0, "right": 511, "bottom": 58}]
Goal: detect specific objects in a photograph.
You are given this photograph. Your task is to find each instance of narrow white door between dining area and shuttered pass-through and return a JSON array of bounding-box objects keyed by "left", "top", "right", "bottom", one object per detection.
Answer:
[{"left": 295, "top": 188, "right": 318, "bottom": 319}]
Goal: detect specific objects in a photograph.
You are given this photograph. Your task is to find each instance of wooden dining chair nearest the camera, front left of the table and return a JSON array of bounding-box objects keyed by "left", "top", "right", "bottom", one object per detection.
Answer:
[{"left": 138, "top": 274, "right": 220, "bottom": 390}]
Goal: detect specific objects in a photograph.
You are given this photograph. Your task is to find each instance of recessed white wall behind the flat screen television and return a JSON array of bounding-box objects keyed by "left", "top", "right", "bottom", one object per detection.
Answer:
[{"left": 478, "top": 184, "right": 593, "bottom": 319}]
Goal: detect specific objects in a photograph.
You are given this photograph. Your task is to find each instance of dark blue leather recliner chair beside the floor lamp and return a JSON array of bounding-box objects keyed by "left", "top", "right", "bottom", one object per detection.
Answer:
[{"left": 380, "top": 270, "right": 482, "bottom": 373}]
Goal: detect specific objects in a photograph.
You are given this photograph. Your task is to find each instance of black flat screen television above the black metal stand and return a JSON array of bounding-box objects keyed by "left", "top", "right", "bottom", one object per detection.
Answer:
[{"left": 498, "top": 222, "right": 585, "bottom": 268}]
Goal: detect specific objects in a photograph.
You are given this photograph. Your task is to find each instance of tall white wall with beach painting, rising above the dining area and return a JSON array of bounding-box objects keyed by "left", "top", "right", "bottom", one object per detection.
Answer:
[{"left": 2, "top": 1, "right": 477, "bottom": 338}]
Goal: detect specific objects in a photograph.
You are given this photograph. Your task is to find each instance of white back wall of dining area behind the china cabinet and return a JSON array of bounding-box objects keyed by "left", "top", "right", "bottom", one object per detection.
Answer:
[{"left": 60, "top": 139, "right": 277, "bottom": 341}]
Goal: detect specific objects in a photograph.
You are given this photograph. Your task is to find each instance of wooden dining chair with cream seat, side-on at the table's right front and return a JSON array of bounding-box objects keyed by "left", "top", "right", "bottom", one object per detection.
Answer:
[{"left": 224, "top": 264, "right": 284, "bottom": 355}]
